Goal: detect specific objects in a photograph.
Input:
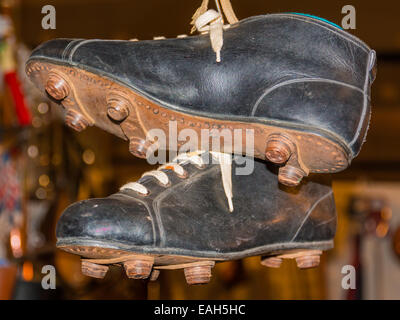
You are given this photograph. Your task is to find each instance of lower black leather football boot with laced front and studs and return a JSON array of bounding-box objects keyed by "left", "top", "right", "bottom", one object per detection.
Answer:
[{"left": 56, "top": 152, "right": 336, "bottom": 284}]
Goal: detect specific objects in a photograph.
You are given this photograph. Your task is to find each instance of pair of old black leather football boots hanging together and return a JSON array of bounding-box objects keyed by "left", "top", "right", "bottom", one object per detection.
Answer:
[{"left": 26, "top": 10, "right": 376, "bottom": 284}]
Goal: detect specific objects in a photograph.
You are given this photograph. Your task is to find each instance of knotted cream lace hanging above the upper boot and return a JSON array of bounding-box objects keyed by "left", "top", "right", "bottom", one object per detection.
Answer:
[{"left": 191, "top": 0, "right": 238, "bottom": 62}]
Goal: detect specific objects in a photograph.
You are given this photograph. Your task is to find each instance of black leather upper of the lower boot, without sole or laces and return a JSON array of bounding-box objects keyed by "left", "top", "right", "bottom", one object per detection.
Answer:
[{"left": 56, "top": 154, "right": 336, "bottom": 256}]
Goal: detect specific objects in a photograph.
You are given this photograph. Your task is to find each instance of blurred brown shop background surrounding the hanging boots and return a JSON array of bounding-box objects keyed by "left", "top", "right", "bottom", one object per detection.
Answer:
[{"left": 0, "top": 0, "right": 400, "bottom": 299}]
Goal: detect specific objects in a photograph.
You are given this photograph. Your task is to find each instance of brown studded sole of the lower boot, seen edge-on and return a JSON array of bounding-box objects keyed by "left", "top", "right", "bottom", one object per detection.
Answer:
[{"left": 57, "top": 240, "right": 333, "bottom": 285}]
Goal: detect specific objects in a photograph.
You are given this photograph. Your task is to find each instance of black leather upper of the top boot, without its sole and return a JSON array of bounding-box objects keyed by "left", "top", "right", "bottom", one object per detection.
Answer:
[{"left": 30, "top": 14, "right": 375, "bottom": 157}]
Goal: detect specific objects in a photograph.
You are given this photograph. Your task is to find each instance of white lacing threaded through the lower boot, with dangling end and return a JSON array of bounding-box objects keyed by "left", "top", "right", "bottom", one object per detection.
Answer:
[{"left": 120, "top": 151, "right": 233, "bottom": 212}]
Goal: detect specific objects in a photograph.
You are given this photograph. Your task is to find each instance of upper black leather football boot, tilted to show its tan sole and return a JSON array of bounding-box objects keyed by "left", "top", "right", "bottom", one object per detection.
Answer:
[{"left": 26, "top": 14, "right": 376, "bottom": 185}]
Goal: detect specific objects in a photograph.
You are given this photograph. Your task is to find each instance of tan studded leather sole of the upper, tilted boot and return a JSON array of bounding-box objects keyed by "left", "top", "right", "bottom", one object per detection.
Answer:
[{"left": 26, "top": 59, "right": 351, "bottom": 186}]
